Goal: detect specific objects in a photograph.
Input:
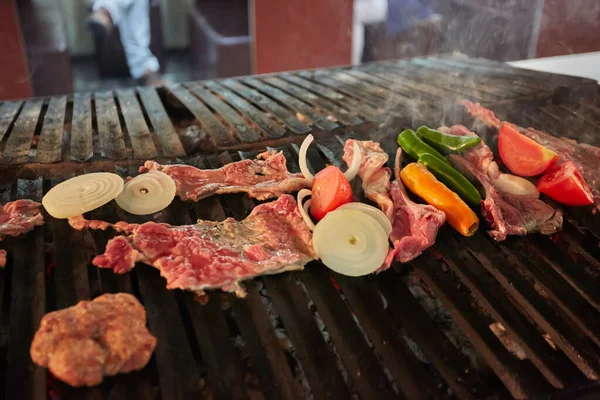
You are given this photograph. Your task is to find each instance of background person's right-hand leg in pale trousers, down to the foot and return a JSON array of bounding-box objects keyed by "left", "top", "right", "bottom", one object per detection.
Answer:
[{"left": 119, "top": 0, "right": 160, "bottom": 80}]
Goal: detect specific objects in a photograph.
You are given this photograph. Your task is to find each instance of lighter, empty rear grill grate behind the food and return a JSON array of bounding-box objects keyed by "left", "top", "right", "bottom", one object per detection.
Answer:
[{"left": 0, "top": 52, "right": 600, "bottom": 168}]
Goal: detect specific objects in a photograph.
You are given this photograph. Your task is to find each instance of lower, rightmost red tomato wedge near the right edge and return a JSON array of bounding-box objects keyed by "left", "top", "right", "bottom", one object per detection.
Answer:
[{"left": 536, "top": 161, "right": 594, "bottom": 206}]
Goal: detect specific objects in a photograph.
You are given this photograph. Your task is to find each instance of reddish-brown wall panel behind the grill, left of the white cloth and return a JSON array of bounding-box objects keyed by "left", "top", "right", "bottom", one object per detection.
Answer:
[{"left": 250, "top": 0, "right": 354, "bottom": 73}]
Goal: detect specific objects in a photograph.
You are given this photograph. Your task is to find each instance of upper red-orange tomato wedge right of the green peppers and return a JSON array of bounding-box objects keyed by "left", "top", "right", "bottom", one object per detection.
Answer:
[{"left": 498, "top": 123, "right": 558, "bottom": 176}]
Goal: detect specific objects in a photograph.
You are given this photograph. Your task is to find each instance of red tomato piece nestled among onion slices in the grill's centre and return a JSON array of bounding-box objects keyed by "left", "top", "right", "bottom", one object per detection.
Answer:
[{"left": 310, "top": 166, "right": 352, "bottom": 221}]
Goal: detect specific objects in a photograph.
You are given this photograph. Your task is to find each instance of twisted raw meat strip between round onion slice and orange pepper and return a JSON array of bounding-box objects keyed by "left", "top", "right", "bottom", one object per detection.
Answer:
[{"left": 343, "top": 139, "right": 446, "bottom": 272}]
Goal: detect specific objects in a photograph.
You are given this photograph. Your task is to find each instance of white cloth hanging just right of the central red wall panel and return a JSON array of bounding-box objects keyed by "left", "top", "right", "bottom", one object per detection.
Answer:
[{"left": 352, "top": 0, "right": 388, "bottom": 65}]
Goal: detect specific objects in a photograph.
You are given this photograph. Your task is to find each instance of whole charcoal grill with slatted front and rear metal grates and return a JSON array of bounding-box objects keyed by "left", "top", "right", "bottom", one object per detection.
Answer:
[{"left": 0, "top": 56, "right": 600, "bottom": 399}]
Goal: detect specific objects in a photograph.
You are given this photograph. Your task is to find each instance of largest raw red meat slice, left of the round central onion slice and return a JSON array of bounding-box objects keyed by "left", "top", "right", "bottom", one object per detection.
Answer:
[{"left": 92, "top": 195, "right": 315, "bottom": 297}]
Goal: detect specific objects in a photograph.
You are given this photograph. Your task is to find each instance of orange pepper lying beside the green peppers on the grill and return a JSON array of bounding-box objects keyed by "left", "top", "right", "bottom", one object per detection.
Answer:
[{"left": 400, "top": 163, "right": 479, "bottom": 236}]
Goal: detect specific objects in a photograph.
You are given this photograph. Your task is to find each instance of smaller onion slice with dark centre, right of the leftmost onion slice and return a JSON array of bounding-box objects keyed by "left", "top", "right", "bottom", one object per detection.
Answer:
[{"left": 115, "top": 171, "right": 177, "bottom": 215}]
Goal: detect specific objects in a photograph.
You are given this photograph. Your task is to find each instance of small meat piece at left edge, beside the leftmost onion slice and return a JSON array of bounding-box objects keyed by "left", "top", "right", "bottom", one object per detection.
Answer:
[{"left": 0, "top": 199, "right": 44, "bottom": 267}]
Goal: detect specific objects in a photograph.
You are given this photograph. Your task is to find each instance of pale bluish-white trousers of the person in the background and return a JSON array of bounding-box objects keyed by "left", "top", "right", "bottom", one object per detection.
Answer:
[{"left": 93, "top": 0, "right": 160, "bottom": 79}]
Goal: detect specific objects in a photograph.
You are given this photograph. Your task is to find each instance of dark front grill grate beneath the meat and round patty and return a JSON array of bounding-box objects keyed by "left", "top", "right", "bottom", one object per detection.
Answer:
[{"left": 0, "top": 135, "right": 600, "bottom": 399}]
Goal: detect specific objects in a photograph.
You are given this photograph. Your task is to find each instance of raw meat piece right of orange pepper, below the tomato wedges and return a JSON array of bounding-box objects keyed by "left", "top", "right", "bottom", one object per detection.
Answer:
[{"left": 448, "top": 154, "right": 562, "bottom": 242}]
